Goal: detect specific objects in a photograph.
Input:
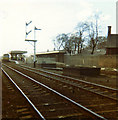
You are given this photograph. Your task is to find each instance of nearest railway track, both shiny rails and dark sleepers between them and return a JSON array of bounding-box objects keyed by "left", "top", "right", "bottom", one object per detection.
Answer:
[{"left": 2, "top": 63, "right": 105, "bottom": 120}]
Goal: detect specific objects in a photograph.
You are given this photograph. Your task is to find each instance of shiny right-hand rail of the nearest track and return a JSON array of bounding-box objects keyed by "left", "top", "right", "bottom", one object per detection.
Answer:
[{"left": 2, "top": 65, "right": 107, "bottom": 120}]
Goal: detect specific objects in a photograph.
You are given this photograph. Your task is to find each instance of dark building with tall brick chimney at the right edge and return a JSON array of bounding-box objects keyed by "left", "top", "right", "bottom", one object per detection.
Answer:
[{"left": 106, "top": 26, "right": 118, "bottom": 55}]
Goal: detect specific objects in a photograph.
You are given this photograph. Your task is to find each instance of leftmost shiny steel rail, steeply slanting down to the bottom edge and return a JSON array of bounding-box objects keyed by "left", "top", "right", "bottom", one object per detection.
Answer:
[{"left": 1, "top": 68, "right": 46, "bottom": 120}]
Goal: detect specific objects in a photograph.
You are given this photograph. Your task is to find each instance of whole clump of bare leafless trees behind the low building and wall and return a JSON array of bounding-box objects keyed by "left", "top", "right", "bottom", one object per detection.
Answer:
[{"left": 53, "top": 13, "right": 104, "bottom": 54}]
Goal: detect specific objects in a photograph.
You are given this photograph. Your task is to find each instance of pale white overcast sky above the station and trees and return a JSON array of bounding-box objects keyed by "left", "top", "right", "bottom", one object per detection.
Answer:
[{"left": 0, "top": 0, "right": 117, "bottom": 56}]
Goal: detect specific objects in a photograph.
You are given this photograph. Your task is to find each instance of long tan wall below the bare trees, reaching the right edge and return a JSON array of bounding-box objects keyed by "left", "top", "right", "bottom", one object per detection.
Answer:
[{"left": 64, "top": 55, "right": 118, "bottom": 68}]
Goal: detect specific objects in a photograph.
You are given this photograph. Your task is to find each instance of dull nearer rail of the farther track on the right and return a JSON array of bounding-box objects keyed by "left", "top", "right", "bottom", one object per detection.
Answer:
[{"left": 6, "top": 63, "right": 118, "bottom": 101}]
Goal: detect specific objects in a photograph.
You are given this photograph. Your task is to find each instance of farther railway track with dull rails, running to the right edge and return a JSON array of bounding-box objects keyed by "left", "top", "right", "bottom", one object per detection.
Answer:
[{"left": 9, "top": 65, "right": 118, "bottom": 100}]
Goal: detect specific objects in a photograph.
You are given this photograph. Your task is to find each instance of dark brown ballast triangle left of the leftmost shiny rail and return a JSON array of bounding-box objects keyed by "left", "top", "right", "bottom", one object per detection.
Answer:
[{"left": 1, "top": 72, "right": 38, "bottom": 120}]
